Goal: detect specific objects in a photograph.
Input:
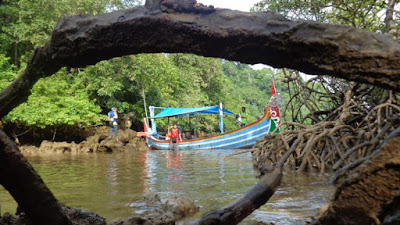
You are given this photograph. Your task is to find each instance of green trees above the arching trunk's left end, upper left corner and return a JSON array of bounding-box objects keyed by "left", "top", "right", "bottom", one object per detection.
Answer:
[{"left": 0, "top": 0, "right": 141, "bottom": 66}]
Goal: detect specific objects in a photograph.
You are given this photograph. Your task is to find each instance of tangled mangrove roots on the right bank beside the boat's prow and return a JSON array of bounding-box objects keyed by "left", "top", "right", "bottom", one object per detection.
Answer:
[{"left": 253, "top": 72, "right": 400, "bottom": 178}]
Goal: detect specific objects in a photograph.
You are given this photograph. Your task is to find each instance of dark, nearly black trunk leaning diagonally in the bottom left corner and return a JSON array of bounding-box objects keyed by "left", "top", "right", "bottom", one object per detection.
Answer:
[{"left": 0, "top": 130, "right": 72, "bottom": 225}]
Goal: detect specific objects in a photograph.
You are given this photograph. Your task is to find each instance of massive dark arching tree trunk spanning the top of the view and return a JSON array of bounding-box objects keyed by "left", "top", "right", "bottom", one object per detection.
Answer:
[{"left": 0, "top": 4, "right": 400, "bottom": 118}]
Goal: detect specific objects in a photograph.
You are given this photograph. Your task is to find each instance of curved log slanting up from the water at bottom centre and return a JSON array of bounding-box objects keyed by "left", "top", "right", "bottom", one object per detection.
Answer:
[{"left": 195, "top": 167, "right": 282, "bottom": 225}]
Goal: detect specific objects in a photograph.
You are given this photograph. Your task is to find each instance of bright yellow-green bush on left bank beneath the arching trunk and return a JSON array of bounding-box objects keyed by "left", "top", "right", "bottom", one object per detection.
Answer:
[{"left": 4, "top": 72, "right": 107, "bottom": 128}]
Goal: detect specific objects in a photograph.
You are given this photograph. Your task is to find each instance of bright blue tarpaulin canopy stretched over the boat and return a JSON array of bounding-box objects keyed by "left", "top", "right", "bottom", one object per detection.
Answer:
[{"left": 152, "top": 106, "right": 235, "bottom": 119}]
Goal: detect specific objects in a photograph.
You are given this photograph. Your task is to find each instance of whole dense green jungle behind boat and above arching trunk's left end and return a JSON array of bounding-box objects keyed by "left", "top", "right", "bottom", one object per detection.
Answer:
[{"left": 0, "top": 0, "right": 288, "bottom": 137}]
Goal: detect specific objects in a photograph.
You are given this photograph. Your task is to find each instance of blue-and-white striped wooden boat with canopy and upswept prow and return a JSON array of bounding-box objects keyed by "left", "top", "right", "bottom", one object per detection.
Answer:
[{"left": 145, "top": 105, "right": 276, "bottom": 150}]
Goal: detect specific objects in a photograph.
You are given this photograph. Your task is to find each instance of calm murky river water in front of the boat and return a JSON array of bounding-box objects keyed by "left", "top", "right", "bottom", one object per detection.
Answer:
[{"left": 0, "top": 150, "right": 334, "bottom": 224}]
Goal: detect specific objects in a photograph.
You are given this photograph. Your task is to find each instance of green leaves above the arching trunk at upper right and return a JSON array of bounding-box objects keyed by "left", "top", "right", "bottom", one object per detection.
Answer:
[{"left": 253, "top": 0, "right": 387, "bottom": 32}]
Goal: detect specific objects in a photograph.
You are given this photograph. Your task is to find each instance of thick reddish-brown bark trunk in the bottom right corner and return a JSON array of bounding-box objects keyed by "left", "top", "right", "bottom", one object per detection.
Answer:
[{"left": 318, "top": 128, "right": 400, "bottom": 225}]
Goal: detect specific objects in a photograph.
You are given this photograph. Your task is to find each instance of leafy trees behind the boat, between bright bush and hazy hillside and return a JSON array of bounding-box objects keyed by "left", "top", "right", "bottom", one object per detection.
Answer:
[{"left": 72, "top": 54, "right": 255, "bottom": 132}]
